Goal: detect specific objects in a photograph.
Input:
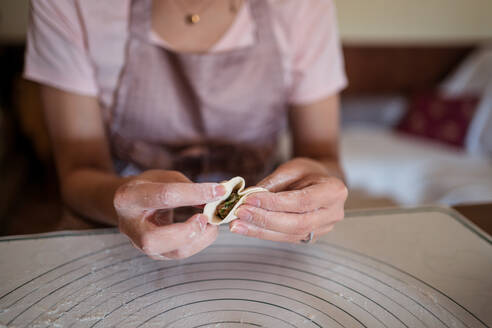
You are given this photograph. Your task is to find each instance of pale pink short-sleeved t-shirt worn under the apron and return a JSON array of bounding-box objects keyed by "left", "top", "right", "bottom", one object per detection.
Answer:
[{"left": 24, "top": 0, "right": 347, "bottom": 107}]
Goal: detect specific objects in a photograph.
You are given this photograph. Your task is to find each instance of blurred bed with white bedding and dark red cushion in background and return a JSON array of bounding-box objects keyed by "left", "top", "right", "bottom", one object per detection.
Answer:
[{"left": 341, "top": 45, "right": 492, "bottom": 208}]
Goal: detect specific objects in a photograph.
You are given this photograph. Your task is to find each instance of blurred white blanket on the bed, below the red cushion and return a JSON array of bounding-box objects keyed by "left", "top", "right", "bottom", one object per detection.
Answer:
[{"left": 341, "top": 127, "right": 492, "bottom": 205}]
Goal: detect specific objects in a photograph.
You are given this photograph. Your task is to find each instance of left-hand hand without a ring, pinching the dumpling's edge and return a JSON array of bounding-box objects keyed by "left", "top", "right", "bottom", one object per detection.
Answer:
[{"left": 114, "top": 170, "right": 225, "bottom": 260}]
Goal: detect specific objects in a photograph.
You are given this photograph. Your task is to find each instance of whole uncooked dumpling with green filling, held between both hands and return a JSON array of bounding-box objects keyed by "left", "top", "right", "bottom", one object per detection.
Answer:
[{"left": 203, "top": 177, "right": 268, "bottom": 225}]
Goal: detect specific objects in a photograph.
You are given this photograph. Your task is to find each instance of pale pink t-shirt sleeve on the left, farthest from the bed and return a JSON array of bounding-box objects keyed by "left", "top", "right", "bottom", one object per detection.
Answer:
[{"left": 24, "top": 0, "right": 98, "bottom": 96}]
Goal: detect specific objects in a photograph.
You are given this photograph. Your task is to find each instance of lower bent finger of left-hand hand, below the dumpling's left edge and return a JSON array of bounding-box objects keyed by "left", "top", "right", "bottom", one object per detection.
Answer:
[{"left": 133, "top": 214, "right": 208, "bottom": 255}]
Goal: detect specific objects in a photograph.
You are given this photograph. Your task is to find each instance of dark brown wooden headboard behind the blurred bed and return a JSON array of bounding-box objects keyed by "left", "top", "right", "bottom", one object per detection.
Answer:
[{"left": 343, "top": 45, "right": 474, "bottom": 94}]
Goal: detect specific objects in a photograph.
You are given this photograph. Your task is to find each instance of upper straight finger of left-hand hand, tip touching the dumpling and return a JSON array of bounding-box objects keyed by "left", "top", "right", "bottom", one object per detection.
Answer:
[{"left": 114, "top": 181, "right": 226, "bottom": 209}]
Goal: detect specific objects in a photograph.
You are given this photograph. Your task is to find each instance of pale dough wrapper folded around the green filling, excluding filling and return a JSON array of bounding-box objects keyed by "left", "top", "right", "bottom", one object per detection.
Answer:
[{"left": 203, "top": 177, "right": 268, "bottom": 225}]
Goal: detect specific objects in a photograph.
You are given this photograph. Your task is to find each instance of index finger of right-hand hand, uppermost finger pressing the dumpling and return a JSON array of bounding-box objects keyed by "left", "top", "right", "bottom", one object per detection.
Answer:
[{"left": 244, "top": 178, "right": 348, "bottom": 213}]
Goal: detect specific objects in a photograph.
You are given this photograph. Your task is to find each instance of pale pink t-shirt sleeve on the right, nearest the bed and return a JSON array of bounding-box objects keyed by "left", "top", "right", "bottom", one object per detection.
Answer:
[{"left": 289, "top": 0, "right": 347, "bottom": 105}]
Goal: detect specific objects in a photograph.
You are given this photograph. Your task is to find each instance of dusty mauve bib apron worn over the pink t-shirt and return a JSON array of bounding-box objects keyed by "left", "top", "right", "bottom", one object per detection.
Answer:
[{"left": 107, "top": 0, "right": 287, "bottom": 184}]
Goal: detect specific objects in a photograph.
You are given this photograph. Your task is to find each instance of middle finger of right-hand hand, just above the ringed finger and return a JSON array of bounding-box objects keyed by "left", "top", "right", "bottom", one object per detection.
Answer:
[{"left": 237, "top": 205, "right": 343, "bottom": 235}]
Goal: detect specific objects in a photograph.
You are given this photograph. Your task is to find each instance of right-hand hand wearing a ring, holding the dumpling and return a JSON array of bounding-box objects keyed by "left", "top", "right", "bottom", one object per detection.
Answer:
[{"left": 230, "top": 158, "right": 348, "bottom": 243}]
